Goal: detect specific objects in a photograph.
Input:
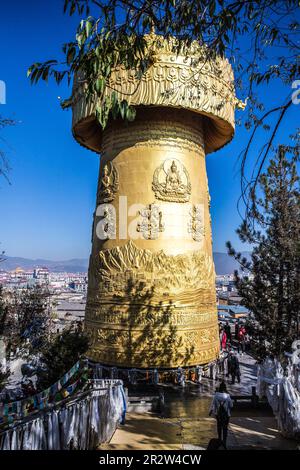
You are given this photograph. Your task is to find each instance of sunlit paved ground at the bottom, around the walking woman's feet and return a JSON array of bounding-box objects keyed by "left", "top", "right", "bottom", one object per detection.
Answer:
[{"left": 101, "top": 413, "right": 297, "bottom": 450}]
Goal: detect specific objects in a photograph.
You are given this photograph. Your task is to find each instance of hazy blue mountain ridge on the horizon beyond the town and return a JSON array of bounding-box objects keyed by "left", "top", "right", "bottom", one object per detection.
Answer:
[{"left": 0, "top": 252, "right": 250, "bottom": 275}]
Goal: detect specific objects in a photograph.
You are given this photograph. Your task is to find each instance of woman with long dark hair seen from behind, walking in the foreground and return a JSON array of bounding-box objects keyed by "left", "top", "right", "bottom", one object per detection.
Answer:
[{"left": 209, "top": 382, "right": 233, "bottom": 449}]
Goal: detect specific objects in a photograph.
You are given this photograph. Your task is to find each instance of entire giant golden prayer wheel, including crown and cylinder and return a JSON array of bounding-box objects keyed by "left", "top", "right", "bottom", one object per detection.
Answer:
[{"left": 73, "top": 34, "right": 238, "bottom": 368}]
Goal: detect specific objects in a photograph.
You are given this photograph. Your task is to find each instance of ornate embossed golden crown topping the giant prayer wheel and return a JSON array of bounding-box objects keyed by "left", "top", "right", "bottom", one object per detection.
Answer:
[{"left": 73, "top": 32, "right": 243, "bottom": 153}]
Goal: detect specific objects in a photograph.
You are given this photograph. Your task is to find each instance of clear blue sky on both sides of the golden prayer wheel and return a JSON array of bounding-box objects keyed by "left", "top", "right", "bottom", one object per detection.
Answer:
[{"left": 0, "top": 0, "right": 300, "bottom": 260}]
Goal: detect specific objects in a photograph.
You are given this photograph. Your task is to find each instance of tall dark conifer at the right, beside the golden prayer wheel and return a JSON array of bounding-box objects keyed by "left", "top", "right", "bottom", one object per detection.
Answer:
[{"left": 227, "top": 146, "right": 300, "bottom": 360}]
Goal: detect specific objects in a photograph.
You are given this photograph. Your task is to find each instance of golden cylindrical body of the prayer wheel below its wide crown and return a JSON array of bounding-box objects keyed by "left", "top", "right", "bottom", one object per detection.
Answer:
[{"left": 85, "top": 107, "right": 219, "bottom": 368}]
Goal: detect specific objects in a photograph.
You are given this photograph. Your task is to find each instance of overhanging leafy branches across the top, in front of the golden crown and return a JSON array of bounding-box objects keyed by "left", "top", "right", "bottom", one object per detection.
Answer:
[{"left": 28, "top": 0, "right": 299, "bottom": 141}]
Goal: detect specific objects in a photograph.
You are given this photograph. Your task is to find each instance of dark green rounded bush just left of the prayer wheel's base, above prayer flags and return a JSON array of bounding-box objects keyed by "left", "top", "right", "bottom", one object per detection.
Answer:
[{"left": 38, "top": 324, "right": 88, "bottom": 390}]
